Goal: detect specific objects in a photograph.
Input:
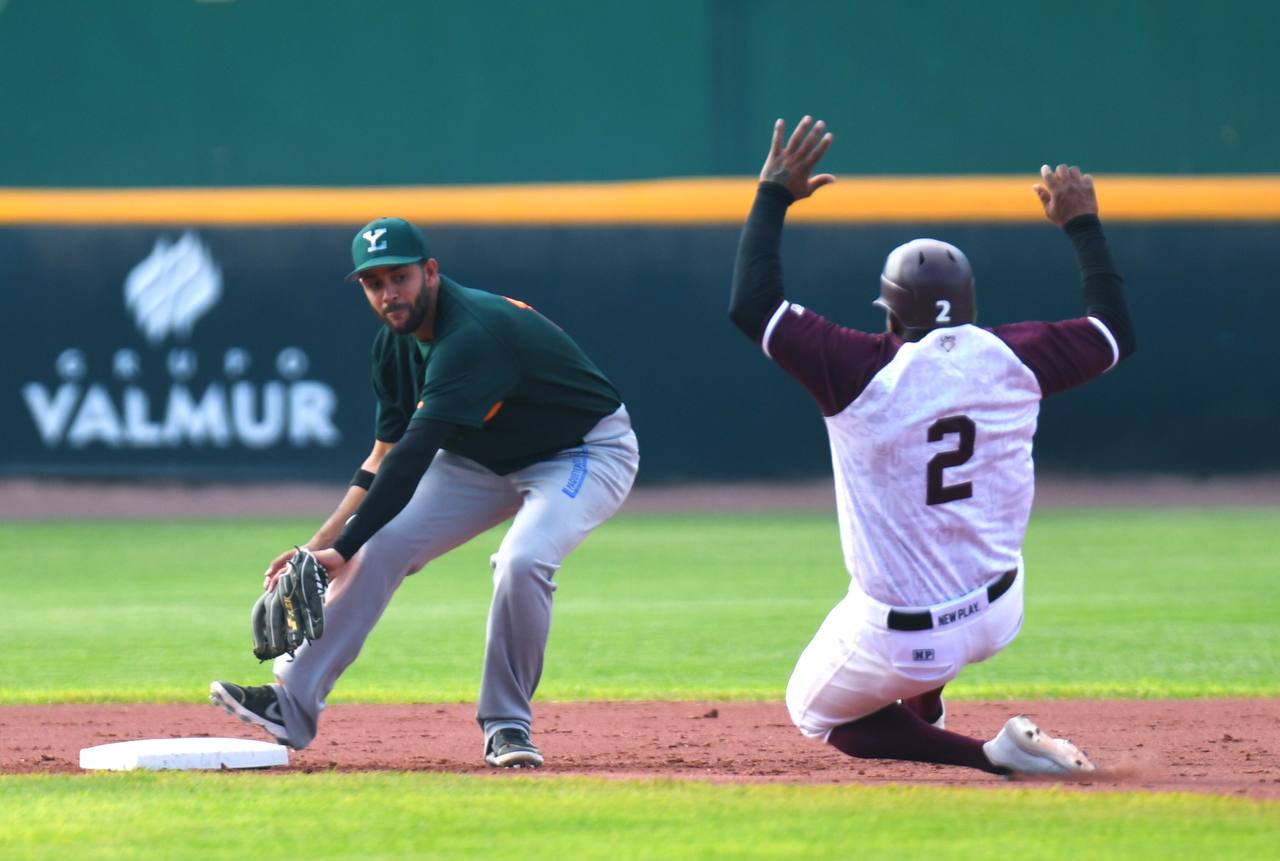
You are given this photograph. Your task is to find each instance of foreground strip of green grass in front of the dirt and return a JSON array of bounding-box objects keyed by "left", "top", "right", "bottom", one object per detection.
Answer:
[{"left": 0, "top": 773, "right": 1280, "bottom": 861}]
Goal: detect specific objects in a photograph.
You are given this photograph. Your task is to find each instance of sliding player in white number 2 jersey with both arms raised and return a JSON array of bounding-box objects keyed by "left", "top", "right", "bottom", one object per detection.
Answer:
[{"left": 730, "top": 116, "right": 1134, "bottom": 774}]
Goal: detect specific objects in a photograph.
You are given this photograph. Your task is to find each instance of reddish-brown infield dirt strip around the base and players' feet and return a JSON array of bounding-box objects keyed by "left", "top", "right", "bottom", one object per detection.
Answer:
[{"left": 0, "top": 700, "right": 1280, "bottom": 800}]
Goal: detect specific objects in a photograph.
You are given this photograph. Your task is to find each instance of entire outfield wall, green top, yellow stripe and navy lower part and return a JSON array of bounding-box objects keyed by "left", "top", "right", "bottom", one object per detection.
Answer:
[{"left": 0, "top": 0, "right": 1280, "bottom": 481}]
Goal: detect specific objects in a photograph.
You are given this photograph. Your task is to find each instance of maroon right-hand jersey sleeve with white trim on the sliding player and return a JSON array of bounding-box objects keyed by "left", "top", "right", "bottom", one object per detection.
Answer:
[{"left": 991, "top": 317, "right": 1116, "bottom": 398}]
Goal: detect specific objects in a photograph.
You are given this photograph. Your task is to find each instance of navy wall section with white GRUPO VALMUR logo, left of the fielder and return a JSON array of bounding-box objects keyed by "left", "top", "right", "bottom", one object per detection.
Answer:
[{"left": 0, "top": 229, "right": 376, "bottom": 480}]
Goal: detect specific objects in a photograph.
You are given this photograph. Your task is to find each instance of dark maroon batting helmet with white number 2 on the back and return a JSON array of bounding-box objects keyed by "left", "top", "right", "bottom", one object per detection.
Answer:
[{"left": 872, "top": 239, "right": 978, "bottom": 333}]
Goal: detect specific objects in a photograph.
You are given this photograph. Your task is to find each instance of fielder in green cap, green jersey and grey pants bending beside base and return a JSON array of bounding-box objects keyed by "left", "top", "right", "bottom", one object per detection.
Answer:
[{"left": 210, "top": 217, "right": 650, "bottom": 768}]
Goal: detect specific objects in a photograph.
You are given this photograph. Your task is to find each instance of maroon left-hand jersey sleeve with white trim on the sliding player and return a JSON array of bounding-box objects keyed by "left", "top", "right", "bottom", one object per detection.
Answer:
[{"left": 763, "top": 302, "right": 902, "bottom": 416}]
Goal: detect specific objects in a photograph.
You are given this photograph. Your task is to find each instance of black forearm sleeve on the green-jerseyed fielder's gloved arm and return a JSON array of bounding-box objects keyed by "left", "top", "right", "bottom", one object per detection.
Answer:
[{"left": 333, "top": 418, "right": 456, "bottom": 559}]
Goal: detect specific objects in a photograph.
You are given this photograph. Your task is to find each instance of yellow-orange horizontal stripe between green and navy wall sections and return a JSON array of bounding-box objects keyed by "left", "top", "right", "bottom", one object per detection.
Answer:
[{"left": 0, "top": 174, "right": 1280, "bottom": 226}]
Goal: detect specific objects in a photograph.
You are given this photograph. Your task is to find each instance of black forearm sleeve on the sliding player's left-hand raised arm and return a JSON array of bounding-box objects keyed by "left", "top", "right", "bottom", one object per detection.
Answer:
[{"left": 728, "top": 183, "right": 795, "bottom": 343}]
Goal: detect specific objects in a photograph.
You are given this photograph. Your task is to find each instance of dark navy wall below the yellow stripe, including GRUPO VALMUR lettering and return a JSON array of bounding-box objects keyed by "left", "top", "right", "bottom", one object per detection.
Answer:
[{"left": 0, "top": 186, "right": 1280, "bottom": 481}]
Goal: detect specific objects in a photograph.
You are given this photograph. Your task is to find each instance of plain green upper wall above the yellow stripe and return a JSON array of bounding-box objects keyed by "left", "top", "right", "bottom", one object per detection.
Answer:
[{"left": 0, "top": 0, "right": 1280, "bottom": 187}]
